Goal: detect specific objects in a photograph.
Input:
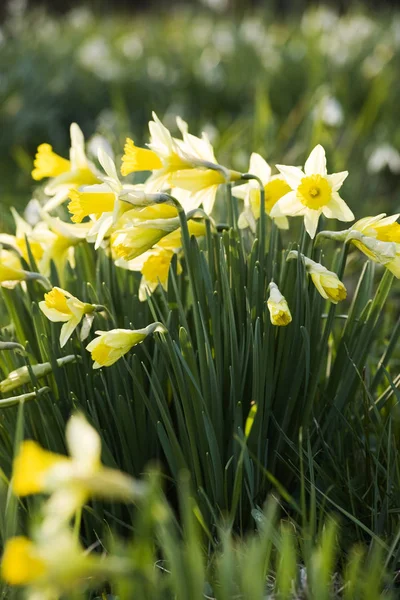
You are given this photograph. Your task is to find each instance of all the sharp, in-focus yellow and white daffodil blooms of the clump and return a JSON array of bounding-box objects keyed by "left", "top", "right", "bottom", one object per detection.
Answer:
[{"left": 0, "top": 113, "right": 400, "bottom": 368}]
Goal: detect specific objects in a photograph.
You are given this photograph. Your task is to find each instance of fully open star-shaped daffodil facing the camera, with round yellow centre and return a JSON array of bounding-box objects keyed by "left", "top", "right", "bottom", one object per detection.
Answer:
[{"left": 271, "top": 145, "right": 354, "bottom": 238}]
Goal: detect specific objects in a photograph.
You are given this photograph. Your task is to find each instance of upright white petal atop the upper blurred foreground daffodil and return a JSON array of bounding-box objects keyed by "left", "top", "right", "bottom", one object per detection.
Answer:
[{"left": 65, "top": 414, "right": 101, "bottom": 473}]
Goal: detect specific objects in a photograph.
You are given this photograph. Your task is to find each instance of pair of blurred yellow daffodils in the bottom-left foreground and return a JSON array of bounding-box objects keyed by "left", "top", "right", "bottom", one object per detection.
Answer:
[{"left": 1, "top": 414, "right": 146, "bottom": 600}]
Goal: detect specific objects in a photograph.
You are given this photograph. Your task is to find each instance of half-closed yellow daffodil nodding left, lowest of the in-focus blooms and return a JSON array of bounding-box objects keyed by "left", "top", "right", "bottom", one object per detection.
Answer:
[{"left": 86, "top": 323, "right": 166, "bottom": 369}]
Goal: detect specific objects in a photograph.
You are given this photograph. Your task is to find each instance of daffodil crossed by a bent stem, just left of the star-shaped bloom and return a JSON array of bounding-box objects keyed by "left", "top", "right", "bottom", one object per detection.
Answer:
[{"left": 232, "top": 152, "right": 291, "bottom": 232}]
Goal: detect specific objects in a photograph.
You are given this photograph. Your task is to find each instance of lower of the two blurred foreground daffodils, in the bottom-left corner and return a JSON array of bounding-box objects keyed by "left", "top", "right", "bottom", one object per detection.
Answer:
[{"left": 1, "top": 527, "right": 127, "bottom": 600}]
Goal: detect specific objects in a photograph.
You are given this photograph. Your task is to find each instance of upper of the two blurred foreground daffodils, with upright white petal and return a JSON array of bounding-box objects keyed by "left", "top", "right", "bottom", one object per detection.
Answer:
[{"left": 12, "top": 414, "right": 143, "bottom": 531}]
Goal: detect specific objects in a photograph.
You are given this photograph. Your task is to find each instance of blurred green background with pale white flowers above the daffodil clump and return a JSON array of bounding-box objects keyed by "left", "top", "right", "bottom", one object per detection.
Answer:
[{"left": 0, "top": 0, "right": 400, "bottom": 229}]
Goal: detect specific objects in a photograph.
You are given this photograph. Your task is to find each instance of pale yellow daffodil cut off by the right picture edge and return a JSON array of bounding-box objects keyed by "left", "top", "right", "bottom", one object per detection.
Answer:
[{"left": 318, "top": 213, "right": 400, "bottom": 279}]
